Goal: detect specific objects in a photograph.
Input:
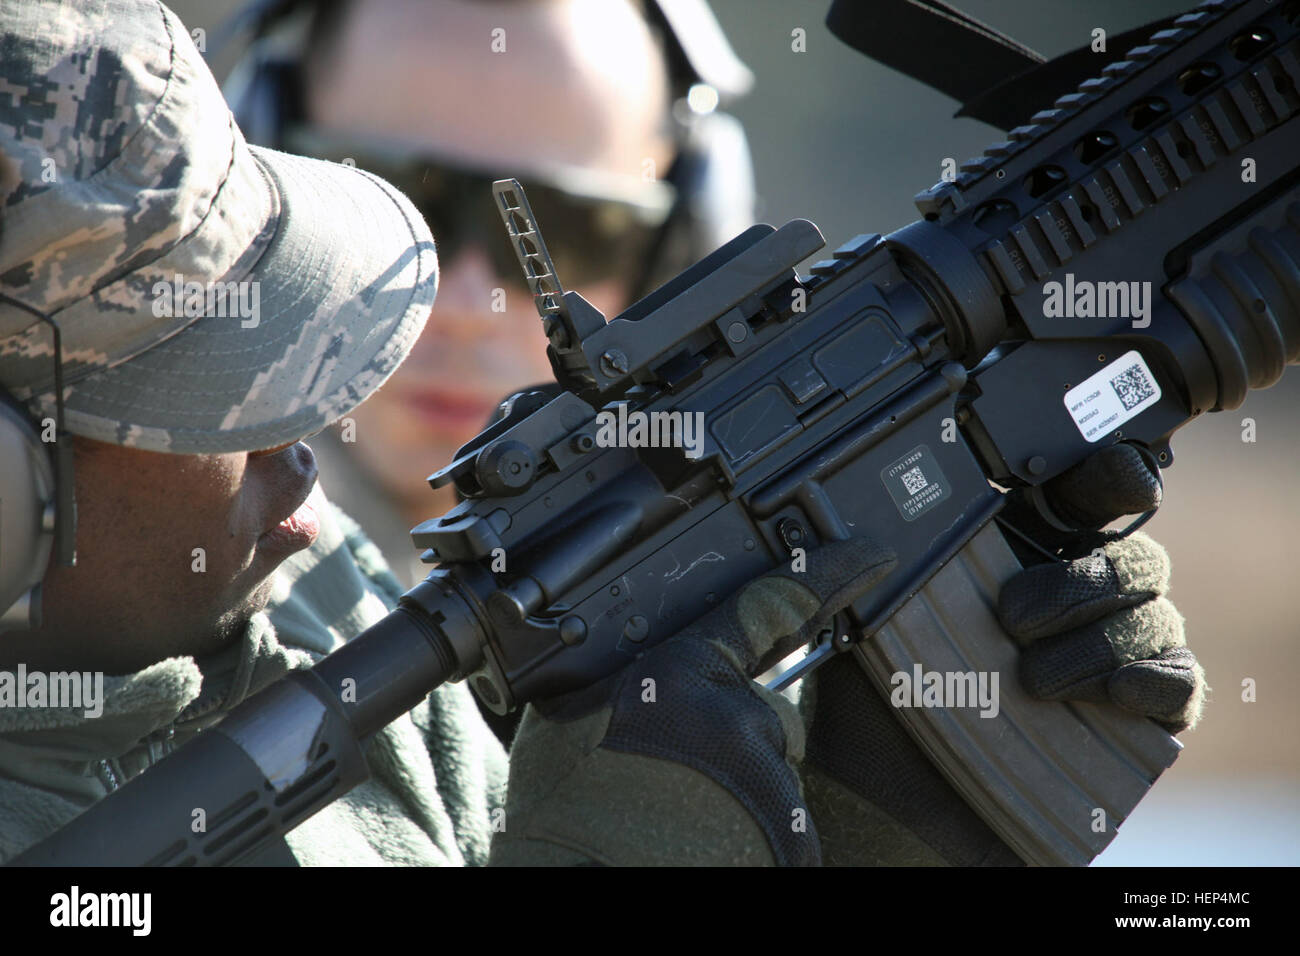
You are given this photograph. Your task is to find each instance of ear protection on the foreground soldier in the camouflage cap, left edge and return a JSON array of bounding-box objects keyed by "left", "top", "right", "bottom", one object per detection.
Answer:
[{"left": 0, "top": 293, "right": 77, "bottom": 632}]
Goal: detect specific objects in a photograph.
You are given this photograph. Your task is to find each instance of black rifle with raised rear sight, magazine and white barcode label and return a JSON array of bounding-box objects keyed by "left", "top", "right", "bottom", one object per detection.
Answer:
[{"left": 17, "top": 0, "right": 1300, "bottom": 864}]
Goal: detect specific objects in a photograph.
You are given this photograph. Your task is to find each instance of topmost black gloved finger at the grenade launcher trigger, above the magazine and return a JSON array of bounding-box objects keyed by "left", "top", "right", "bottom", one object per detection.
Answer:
[{"left": 1043, "top": 442, "right": 1162, "bottom": 528}]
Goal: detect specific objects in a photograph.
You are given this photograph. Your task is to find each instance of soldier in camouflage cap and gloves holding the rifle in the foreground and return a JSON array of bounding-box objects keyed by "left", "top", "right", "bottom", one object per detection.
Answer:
[{"left": 0, "top": 0, "right": 1203, "bottom": 864}]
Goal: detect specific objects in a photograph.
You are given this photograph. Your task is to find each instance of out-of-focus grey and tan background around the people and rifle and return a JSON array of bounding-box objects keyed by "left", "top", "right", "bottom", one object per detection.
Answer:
[{"left": 172, "top": 0, "right": 1300, "bottom": 866}]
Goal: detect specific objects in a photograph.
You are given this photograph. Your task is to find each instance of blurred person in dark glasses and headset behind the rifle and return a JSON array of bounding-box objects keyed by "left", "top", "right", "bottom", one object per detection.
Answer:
[{"left": 219, "top": 0, "right": 754, "bottom": 585}]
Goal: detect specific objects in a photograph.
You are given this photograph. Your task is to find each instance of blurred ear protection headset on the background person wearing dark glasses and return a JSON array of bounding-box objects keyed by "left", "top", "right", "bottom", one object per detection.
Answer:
[{"left": 213, "top": 0, "right": 755, "bottom": 300}]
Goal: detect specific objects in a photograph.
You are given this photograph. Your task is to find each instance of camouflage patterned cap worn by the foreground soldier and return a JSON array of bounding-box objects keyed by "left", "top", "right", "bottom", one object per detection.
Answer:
[{"left": 0, "top": 0, "right": 438, "bottom": 454}]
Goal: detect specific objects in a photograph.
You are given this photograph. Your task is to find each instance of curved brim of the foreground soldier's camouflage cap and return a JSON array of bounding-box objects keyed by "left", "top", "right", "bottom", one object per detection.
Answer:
[{"left": 53, "top": 146, "right": 438, "bottom": 454}]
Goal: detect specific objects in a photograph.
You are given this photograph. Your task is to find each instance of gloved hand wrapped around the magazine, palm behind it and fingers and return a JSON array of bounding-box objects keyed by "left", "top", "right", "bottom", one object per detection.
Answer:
[{"left": 800, "top": 445, "right": 1205, "bottom": 865}]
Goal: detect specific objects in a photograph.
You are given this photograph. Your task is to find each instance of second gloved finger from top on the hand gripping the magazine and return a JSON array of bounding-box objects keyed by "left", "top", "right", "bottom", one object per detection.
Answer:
[{"left": 997, "top": 532, "right": 1169, "bottom": 643}]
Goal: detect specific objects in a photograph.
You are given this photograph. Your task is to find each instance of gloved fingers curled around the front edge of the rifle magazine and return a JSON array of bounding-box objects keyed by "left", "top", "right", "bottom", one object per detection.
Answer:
[{"left": 997, "top": 445, "right": 1205, "bottom": 734}]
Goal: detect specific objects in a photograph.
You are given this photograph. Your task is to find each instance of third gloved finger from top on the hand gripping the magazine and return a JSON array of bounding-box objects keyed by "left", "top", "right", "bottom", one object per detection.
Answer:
[{"left": 1021, "top": 598, "right": 1183, "bottom": 701}]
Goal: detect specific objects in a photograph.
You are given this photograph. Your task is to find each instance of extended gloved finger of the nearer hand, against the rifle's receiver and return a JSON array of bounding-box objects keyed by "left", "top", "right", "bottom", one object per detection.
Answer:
[{"left": 672, "top": 537, "right": 897, "bottom": 678}]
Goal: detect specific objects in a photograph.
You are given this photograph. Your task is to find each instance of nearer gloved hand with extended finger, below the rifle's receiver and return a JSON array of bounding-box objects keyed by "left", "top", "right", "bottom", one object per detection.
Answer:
[{"left": 490, "top": 541, "right": 892, "bottom": 865}]
